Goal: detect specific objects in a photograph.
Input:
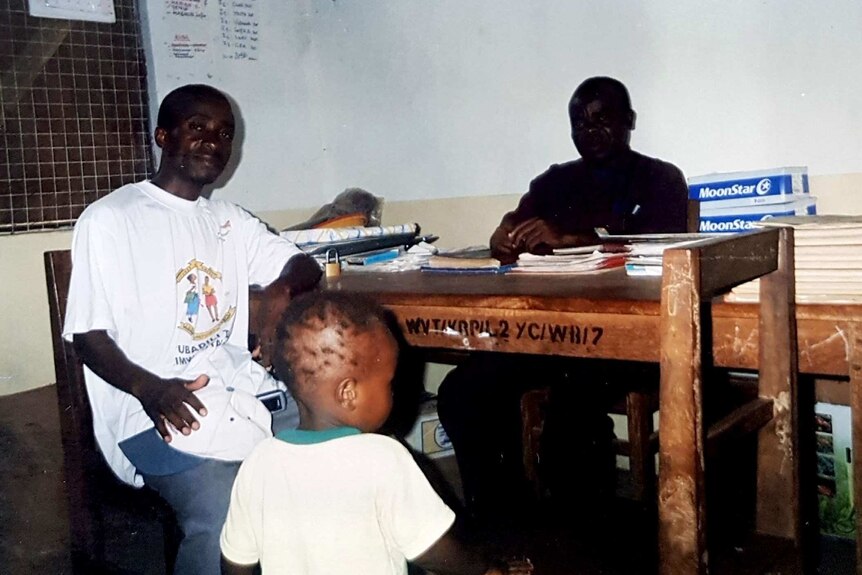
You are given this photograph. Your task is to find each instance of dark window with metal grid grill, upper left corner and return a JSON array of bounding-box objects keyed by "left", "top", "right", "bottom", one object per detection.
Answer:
[{"left": 0, "top": 0, "right": 152, "bottom": 234}]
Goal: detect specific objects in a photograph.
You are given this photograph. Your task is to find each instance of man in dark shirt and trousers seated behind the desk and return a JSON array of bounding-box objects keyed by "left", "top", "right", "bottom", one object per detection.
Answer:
[{"left": 438, "top": 77, "right": 688, "bottom": 517}]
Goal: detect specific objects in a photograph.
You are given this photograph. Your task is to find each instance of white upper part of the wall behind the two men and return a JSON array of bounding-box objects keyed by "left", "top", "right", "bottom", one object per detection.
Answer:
[{"left": 142, "top": 0, "right": 862, "bottom": 210}]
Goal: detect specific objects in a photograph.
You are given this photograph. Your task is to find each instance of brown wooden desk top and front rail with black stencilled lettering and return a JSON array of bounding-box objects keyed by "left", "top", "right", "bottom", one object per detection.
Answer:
[{"left": 318, "top": 269, "right": 862, "bottom": 376}]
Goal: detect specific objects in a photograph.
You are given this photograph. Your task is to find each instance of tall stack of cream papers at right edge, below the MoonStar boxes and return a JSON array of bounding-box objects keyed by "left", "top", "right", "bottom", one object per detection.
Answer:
[{"left": 726, "top": 216, "right": 862, "bottom": 303}]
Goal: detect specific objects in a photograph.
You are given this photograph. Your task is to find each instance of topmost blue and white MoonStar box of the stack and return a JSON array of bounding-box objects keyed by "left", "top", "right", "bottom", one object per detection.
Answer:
[{"left": 688, "top": 167, "right": 808, "bottom": 209}]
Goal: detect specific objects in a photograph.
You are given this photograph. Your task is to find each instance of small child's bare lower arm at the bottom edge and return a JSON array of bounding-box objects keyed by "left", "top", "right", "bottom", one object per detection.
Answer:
[{"left": 413, "top": 533, "right": 533, "bottom": 575}]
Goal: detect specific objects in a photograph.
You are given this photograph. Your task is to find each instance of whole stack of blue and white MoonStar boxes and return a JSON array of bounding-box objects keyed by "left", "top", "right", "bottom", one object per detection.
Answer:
[{"left": 688, "top": 167, "right": 817, "bottom": 233}]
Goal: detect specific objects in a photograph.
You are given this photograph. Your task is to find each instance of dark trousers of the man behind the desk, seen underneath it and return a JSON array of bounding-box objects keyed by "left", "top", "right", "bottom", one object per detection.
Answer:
[{"left": 437, "top": 353, "right": 644, "bottom": 517}]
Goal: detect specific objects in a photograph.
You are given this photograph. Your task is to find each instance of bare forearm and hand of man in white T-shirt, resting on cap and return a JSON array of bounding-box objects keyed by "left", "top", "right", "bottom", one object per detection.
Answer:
[{"left": 73, "top": 330, "right": 209, "bottom": 441}]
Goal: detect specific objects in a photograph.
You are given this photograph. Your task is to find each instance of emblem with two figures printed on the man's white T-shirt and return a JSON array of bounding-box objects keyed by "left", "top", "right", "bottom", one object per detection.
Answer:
[{"left": 175, "top": 259, "right": 236, "bottom": 344}]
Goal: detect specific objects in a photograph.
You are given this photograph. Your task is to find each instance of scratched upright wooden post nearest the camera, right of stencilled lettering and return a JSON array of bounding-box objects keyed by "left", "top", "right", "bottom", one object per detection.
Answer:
[{"left": 658, "top": 251, "right": 709, "bottom": 575}]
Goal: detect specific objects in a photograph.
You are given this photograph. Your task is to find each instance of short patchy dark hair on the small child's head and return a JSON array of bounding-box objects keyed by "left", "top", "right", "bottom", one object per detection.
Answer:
[{"left": 272, "top": 291, "right": 392, "bottom": 393}]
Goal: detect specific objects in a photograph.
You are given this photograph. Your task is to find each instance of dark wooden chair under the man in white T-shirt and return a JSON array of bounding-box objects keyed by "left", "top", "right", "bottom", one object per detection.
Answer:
[{"left": 44, "top": 250, "right": 180, "bottom": 574}]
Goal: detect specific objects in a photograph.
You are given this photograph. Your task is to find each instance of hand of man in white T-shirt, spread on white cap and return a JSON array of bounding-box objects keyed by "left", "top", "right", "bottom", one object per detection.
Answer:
[{"left": 134, "top": 375, "right": 210, "bottom": 442}]
